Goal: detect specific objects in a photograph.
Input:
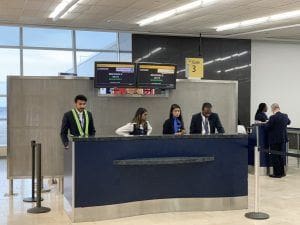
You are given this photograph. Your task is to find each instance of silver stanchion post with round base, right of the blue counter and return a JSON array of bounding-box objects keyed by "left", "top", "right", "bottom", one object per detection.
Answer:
[{"left": 245, "top": 126, "right": 270, "bottom": 220}]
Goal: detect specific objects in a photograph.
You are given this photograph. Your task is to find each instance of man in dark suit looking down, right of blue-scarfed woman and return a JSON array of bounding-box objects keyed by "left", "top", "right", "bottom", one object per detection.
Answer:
[{"left": 190, "top": 102, "right": 225, "bottom": 134}]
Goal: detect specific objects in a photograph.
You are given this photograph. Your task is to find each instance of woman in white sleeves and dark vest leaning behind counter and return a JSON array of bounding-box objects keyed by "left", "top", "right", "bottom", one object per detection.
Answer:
[{"left": 116, "top": 108, "right": 152, "bottom": 136}]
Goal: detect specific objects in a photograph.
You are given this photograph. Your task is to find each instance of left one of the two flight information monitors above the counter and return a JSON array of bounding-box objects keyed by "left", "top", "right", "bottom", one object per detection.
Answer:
[{"left": 94, "top": 62, "right": 136, "bottom": 88}]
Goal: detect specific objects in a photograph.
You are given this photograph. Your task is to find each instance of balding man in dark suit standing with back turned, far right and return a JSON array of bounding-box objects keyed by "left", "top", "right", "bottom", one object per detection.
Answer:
[{"left": 266, "top": 103, "right": 291, "bottom": 178}]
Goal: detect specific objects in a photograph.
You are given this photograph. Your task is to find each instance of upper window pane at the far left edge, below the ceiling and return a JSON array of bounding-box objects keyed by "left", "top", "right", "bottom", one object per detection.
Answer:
[{"left": 0, "top": 26, "right": 20, "bottom": 46}]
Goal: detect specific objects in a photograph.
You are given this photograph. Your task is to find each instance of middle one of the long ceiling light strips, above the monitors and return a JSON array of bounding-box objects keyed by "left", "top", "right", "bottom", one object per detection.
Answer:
[{"left": 137, "top": 0, "right": 219, "bottom": 26}]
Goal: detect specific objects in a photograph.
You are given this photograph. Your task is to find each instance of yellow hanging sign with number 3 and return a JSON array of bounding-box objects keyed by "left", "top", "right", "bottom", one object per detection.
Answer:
[{"left": 185, "top": 58, "right": 203, "bottom": 79}]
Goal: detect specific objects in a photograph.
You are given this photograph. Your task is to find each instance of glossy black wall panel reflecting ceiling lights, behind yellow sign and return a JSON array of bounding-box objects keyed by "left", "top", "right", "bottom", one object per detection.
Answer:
[{"left": 132, "top": 34, "right": 251, "bottom": 125}]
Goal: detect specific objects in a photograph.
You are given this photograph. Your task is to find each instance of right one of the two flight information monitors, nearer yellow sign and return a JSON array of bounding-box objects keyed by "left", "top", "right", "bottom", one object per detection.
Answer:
[{"left": 137, "top": 63, "right": 177, "bottom": 89}]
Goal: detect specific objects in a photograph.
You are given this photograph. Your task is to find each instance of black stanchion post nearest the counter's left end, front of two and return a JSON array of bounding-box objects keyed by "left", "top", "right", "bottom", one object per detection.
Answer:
[{"left": 27, "top": 143, "right": 51, "bottom": 214}]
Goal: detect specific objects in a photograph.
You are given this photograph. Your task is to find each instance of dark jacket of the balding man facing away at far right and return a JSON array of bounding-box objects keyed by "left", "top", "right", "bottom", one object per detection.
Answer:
[{"left": 266, "top": 112, "right": 291, "bottom": 144}]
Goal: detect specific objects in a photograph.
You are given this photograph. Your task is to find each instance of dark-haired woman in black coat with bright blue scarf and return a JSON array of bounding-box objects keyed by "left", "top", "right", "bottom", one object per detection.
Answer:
[{"left": 163, "top": 104, "right": 185, "bottom": 135}]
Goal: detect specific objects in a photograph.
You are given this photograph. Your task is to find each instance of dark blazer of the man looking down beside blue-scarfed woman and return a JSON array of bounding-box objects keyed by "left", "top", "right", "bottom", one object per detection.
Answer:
[{"left": 190, "top": 113, "right": 225, "bottom": 134}]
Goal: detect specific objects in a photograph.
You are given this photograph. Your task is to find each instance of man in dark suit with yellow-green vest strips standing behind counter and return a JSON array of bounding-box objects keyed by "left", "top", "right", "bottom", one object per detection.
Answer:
[{"left": 60, "top": 95, "right": 96, "bottom": 148}]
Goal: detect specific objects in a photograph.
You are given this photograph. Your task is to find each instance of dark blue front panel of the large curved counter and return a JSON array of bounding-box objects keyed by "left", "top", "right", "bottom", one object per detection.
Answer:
[{"left": 65, "top": 135, "right": 248, "bottom": 208}]
